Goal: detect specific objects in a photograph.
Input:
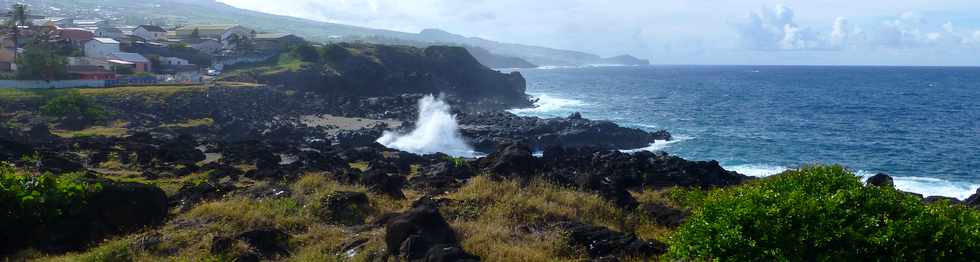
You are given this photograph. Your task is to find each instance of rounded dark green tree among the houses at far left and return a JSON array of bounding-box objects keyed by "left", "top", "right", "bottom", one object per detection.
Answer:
[{"left": 17, "top": 43, "right": 68, "bottom": 80}]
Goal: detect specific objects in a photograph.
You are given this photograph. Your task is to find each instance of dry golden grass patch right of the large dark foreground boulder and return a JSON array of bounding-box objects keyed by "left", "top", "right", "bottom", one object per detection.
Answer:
[{"left": 447, "top": 177, "right": 668, "bottom": 261}]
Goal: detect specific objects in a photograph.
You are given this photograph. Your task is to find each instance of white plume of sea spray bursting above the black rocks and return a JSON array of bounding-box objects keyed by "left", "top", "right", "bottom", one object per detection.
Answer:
[{"left": 378, "top": 95, "right": 475, "bottom": 157}]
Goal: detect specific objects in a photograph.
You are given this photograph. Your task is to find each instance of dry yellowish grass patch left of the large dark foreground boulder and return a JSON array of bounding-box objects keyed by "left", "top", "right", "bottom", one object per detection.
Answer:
[{"left": 33, "top": 173, "right": 418, "bottom": 261}]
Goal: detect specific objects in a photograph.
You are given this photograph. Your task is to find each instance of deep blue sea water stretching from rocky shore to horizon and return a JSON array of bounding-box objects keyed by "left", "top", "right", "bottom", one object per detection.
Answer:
[{"left": 512, "top": 66, "right": 980, "bottom": 199}]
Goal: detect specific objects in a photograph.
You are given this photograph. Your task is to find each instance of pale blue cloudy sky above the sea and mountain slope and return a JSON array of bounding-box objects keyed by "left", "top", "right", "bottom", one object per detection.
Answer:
[{"left": 219, "top": 0, "right": 980, "bottom": 65}]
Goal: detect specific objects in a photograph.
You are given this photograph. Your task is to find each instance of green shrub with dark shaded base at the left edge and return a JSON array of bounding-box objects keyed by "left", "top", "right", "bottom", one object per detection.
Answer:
[{"left": 0, "top": 163, "right": 102, "bottom": 225}]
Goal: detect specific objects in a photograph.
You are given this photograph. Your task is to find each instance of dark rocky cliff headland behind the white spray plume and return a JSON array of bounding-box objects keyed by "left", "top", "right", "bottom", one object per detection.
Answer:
[{"left": 224, "top": 43, "right": 530, "bottom": 109}]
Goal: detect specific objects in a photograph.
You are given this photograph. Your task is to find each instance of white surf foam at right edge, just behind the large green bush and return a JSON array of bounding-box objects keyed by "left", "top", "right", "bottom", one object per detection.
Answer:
[{"left": 856, "top": 170, "right": 980, "bottom": 200}]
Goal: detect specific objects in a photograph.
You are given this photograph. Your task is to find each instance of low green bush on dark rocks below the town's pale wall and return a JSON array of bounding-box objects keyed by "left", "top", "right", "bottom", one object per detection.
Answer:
[{"left": 41, "top": 90, "right": 108, "bottom": 121}]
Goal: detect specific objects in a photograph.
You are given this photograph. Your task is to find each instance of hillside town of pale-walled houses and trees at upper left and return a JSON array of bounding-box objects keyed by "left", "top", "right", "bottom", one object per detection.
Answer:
[{"left": 0, "top": 4, "right": 306, "bottom": 88}]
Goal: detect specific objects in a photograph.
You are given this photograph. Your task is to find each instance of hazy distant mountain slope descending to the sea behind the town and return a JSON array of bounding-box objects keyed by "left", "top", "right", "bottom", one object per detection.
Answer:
[{"left": 9, "top": 0, "right": 649, "bottom": 67}]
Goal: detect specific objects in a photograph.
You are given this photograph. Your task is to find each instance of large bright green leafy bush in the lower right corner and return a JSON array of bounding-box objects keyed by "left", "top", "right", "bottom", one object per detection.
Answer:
[{"left": 669, "top": 166, "right": 980, "bottom": 261}]
